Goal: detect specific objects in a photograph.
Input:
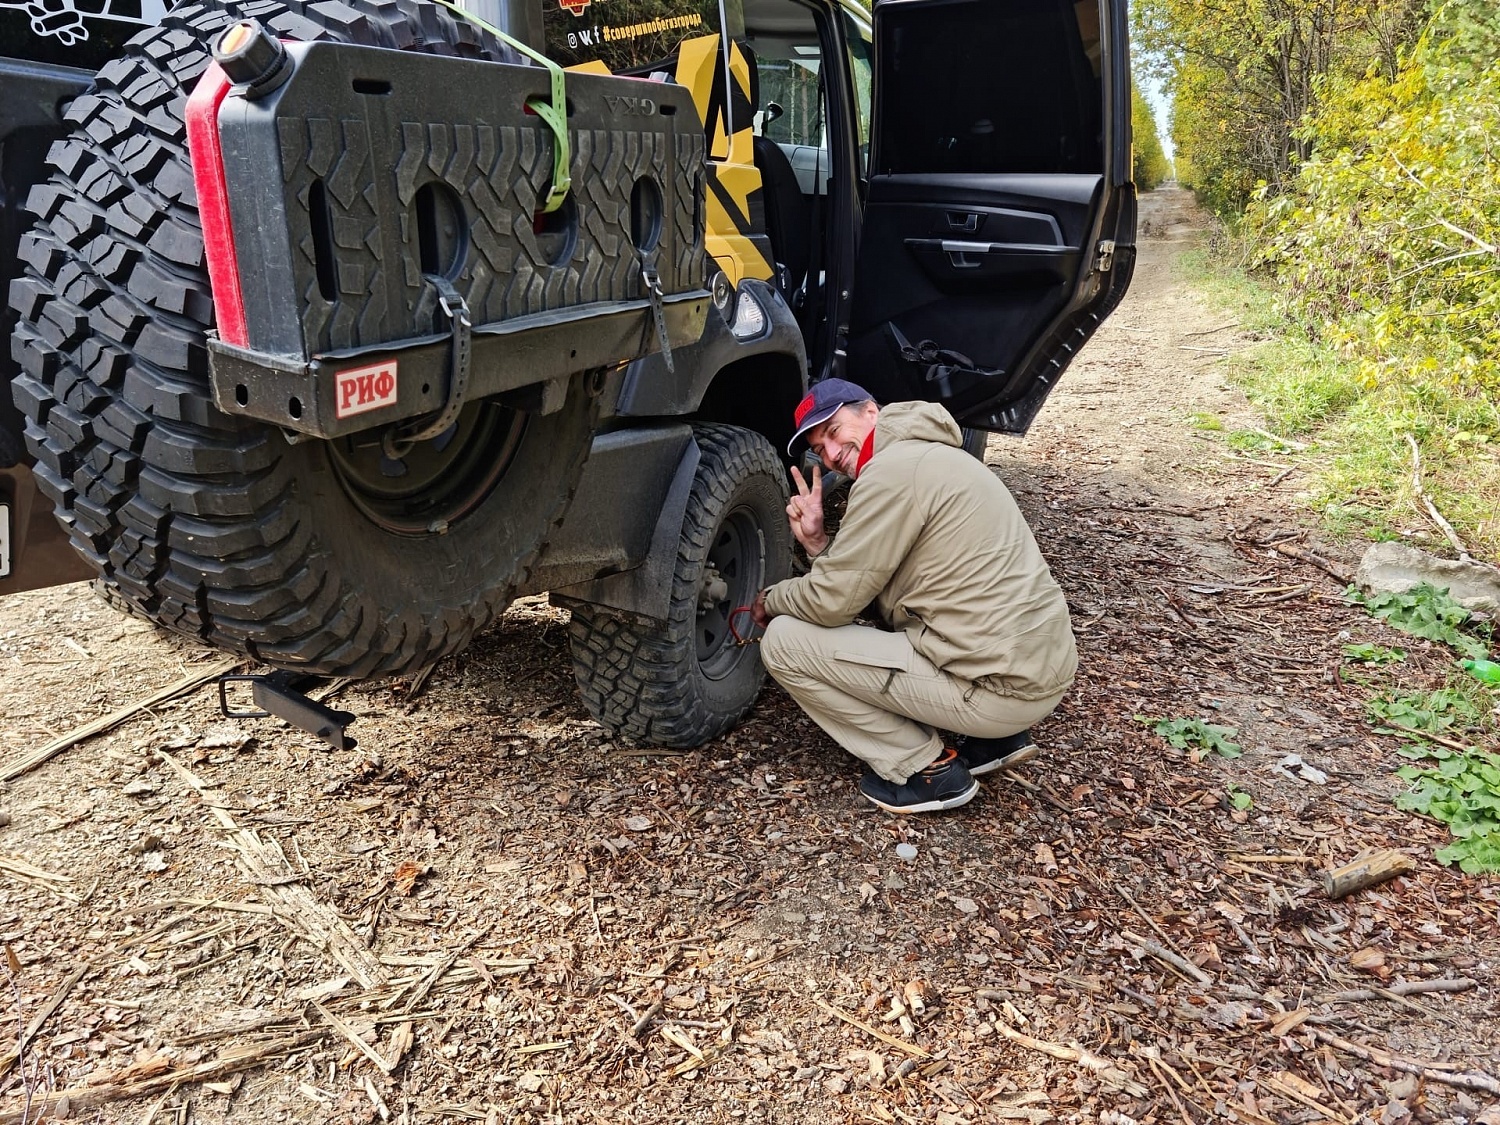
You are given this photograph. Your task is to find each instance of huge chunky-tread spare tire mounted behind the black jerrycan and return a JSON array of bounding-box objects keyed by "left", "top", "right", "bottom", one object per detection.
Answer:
[{"left": 11, "top": 0, "right": 597, "bottom": 677}]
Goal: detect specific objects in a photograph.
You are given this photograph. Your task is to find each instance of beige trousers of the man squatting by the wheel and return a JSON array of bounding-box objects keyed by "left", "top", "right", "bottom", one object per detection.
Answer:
[{"left": 761, "top": 617, "right": 1065, "bottom": 785}]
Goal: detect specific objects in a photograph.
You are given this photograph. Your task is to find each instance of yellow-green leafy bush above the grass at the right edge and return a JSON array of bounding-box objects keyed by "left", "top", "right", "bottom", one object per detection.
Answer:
[{"left": 1245, "top": 3, "right": 1500, "bottom": 402}]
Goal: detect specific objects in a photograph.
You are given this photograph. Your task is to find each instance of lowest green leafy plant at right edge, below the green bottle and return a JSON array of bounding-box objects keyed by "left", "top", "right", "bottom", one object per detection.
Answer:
[{"left": 1397, "top": 743, "right": 1500, "bottom": 875}]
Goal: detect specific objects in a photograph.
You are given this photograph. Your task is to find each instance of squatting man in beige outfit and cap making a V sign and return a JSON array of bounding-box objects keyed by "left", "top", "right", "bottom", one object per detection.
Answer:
[{"left": 752, "top": 380, "right": 1077, "bottom": 813}]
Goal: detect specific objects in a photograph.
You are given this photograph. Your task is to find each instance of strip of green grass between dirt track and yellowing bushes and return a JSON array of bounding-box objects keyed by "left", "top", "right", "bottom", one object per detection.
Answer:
[{"left": 1181, "top": 247, "right": 1500, "bottom": 560}]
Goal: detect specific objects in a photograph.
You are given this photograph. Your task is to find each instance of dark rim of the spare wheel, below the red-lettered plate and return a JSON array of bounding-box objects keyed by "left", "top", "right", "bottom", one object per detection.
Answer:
[{"left": 327, "top": 402, "right": 527, "bottom": 536}]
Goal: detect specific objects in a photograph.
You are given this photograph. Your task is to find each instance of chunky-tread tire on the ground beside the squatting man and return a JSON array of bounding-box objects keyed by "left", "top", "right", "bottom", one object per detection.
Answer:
[{"left": 569, "top": 425, "right": 792, "bottom": 749}]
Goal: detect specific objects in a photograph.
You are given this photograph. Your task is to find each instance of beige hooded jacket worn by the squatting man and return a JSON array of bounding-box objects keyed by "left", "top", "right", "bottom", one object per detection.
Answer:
[{"left": 765, "top": 402, "right": 1079, "bottom": 699}]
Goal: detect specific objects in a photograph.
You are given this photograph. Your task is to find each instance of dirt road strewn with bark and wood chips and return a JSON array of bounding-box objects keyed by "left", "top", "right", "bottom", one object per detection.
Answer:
[{"left": 0, "top": 192, "right": 1500, "bottom": 1125}]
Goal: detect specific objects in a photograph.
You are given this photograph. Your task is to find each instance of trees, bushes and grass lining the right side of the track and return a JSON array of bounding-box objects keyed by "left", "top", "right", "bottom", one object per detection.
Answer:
[{"left": 1134, "top": 0, "right": 1500, "bottom": 561}]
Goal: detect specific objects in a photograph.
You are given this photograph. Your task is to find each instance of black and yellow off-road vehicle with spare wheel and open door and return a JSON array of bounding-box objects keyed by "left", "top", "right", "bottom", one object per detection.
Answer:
[{"left": 0, "top": 0, "right": 1136, "bottom": 746}]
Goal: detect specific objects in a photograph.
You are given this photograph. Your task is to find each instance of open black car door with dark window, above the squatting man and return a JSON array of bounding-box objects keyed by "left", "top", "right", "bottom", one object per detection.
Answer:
[{"left": 846, "top": 0, "right": 1136, "bottom": 434}]
